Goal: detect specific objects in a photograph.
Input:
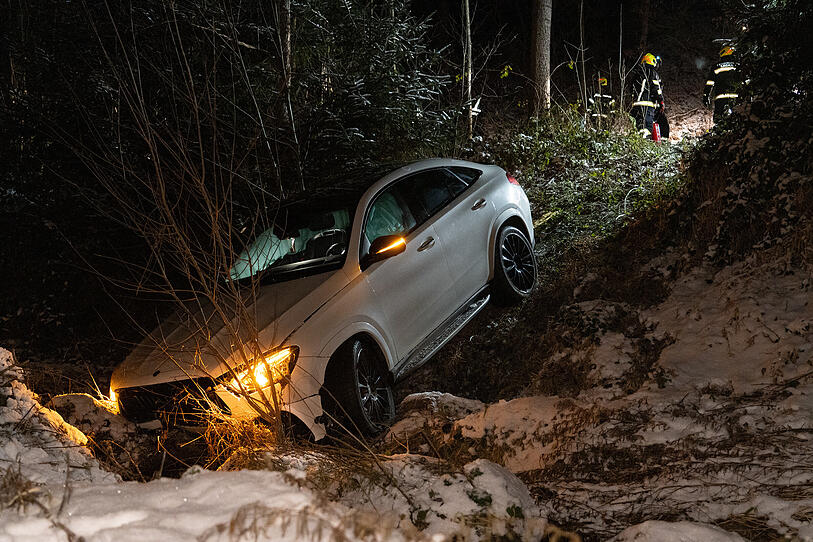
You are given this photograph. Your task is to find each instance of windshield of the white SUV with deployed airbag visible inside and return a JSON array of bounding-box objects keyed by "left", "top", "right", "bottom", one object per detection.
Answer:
[{"left": 229, "top": 194, "right": 358, "bottom": 281}]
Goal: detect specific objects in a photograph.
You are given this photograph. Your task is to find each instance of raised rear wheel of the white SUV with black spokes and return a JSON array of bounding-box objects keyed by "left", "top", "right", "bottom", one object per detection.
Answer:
[{"left": 491, "top": 226, "right": 536, "bottom": 306}]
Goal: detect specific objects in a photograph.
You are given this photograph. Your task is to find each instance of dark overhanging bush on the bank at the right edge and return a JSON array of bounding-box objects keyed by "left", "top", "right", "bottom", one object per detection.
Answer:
[{"left": 689, "top": 0, "right": 813, "bottom": 264}]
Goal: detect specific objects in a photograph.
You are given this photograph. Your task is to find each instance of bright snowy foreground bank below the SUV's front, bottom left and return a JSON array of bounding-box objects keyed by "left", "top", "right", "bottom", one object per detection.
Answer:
[{"left": 0, "top": 349, "right": 546, "bottom": 542}]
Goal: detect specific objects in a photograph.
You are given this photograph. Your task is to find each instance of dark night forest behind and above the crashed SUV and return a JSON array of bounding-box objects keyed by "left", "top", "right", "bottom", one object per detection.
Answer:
[{"left": 0, "top": 0, "right": 807, "bottom": 396}]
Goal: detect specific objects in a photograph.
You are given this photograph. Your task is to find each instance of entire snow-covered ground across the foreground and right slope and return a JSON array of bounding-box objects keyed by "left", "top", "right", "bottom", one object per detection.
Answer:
[{"left": 0, "top": 248, "right": 813, "bottom": 542}]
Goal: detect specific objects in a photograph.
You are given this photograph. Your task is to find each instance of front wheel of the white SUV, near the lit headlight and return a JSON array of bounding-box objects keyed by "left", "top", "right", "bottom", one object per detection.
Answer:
[{"left": 323, "top": 337, "right": 395, "bottom": 437}]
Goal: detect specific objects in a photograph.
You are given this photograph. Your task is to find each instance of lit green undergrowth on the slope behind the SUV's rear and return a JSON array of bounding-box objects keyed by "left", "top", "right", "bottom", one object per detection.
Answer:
[{"left": 475, "top": 114, "right": 682, "bottom": 266}]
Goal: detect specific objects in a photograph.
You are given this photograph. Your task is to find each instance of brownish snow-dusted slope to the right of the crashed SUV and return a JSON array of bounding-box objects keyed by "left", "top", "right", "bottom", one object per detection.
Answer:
[{"left": 389, "top": 254, "right": 813, "bottom": 540}]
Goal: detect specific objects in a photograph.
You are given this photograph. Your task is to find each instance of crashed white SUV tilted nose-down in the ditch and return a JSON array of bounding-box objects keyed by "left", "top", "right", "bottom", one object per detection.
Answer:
[{"left": 110, "top": 159, "right": 536, "bottom": 439}]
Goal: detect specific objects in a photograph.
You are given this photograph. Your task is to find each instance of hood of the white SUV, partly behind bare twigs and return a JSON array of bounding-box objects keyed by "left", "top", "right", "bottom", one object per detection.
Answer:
[{"left": 111, "top": 270, "right": 347, "bottom": 389}]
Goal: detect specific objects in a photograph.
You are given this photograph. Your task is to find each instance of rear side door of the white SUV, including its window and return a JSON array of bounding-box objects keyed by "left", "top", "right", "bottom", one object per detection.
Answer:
[{"left": 398, "top": 168, "right": 494, "bottom": 306}]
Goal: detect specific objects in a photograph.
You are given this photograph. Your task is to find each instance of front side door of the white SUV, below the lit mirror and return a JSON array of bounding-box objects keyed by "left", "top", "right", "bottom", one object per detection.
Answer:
[{"left": 361, "top": 181, "right": 456, "bottom": 360}]
